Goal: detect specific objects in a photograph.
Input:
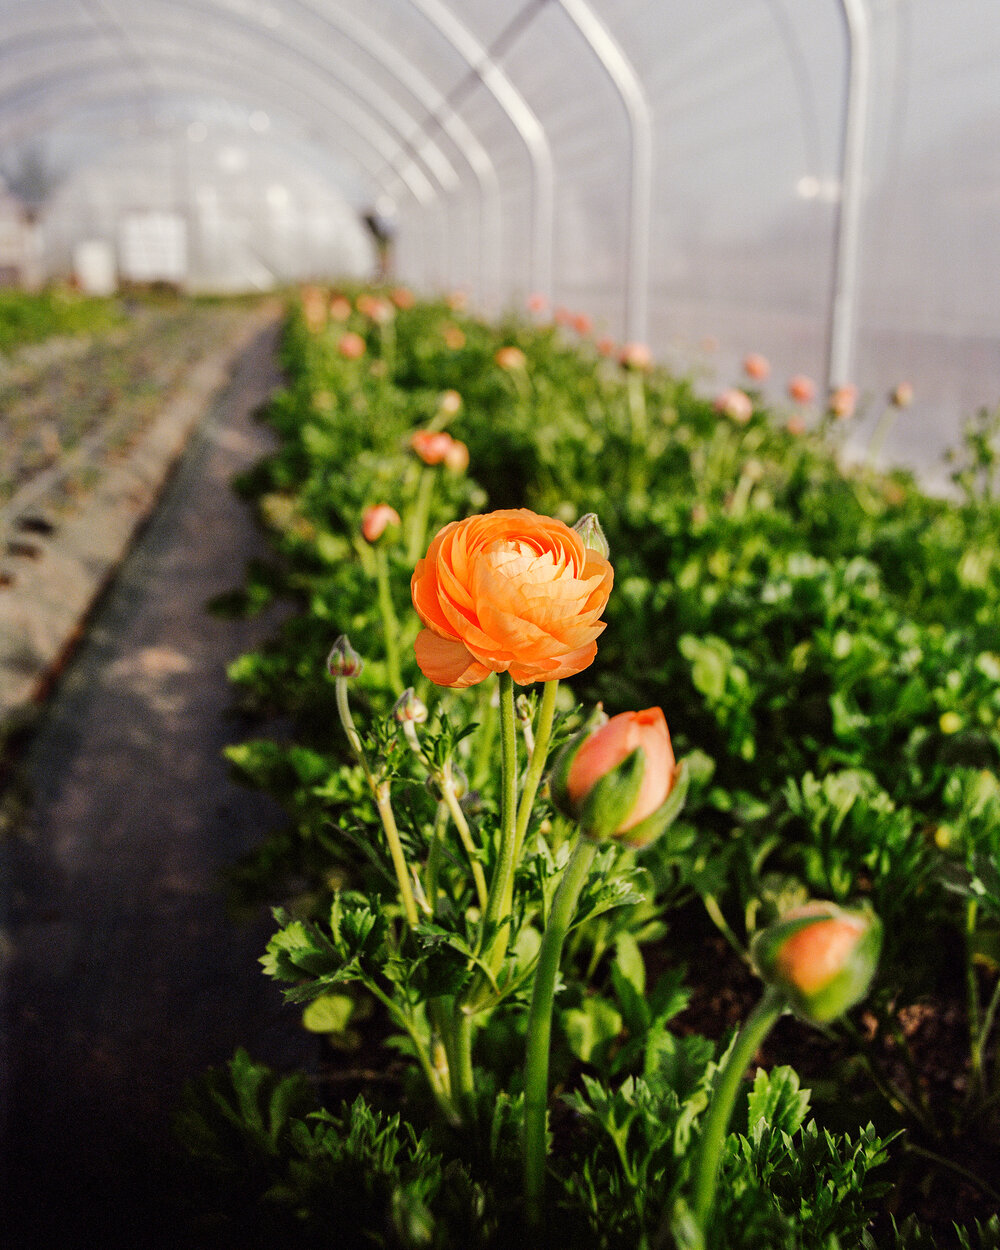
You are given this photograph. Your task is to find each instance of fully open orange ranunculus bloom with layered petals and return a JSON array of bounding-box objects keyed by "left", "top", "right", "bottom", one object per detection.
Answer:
[{"left": 410, "top": 508, "right": 614, "bottom": 686}]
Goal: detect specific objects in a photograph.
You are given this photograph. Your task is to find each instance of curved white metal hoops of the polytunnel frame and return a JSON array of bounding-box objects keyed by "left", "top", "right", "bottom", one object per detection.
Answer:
[{"left": 0, "top": 0, "right": 870, "bottom": 370}]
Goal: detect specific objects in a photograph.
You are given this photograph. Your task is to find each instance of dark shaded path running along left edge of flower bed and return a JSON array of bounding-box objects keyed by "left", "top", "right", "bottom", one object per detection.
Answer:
[{"left": 0, "top": 312, "right": 313, "bottom": 1250}]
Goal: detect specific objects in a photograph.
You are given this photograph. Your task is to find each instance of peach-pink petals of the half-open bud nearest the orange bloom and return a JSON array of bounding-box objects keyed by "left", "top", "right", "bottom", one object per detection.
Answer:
[{"left": 566, "top": 708, "right": 676, "bottom": 836}]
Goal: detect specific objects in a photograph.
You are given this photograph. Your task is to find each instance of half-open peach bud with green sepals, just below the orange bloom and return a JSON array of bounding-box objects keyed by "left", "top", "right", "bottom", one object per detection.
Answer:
[{"left": 551, "top": 708, "right": 683, "bottom": 846}]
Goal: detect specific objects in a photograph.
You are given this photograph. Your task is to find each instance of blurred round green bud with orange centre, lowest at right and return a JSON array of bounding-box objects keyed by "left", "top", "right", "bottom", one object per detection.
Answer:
[{"left": 750, "top": 903, "right": 883, "bottom": 1024}]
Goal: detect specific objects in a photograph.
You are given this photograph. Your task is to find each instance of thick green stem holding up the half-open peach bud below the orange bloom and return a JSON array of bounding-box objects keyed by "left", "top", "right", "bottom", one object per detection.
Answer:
[{"left": 524, "top": 838, "right": 598, "bottom": 1228}]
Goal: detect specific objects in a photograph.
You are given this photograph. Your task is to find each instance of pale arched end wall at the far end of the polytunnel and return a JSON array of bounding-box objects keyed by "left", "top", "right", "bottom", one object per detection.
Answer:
[{"left": 44, "top": 124, "right": 375, "bottom": 294}]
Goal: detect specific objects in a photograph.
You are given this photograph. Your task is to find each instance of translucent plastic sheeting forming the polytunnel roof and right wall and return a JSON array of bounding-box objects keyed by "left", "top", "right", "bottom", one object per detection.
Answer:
[{"left": 0, "top": 0, "right": 1000, "bottom": 477}]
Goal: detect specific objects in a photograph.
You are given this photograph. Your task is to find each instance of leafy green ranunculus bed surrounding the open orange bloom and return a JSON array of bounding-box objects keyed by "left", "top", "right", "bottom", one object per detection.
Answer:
[{"left": 184, "top": 286, "right": 1000, "bottom": 1248}]
